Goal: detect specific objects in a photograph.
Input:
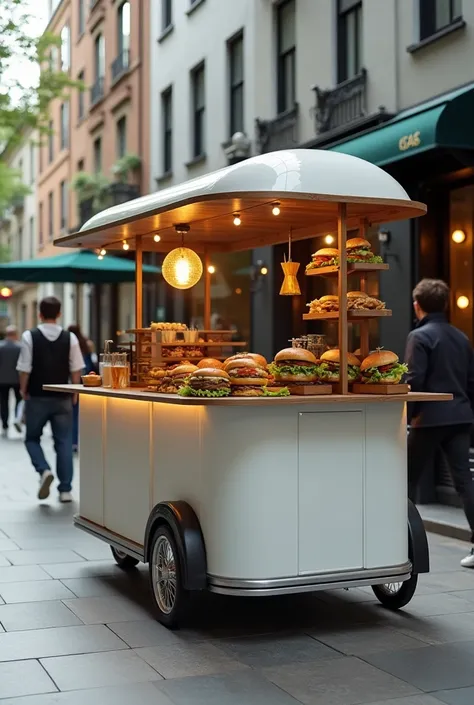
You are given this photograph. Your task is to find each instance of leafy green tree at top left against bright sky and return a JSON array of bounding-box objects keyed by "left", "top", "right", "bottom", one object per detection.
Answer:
[{"left": 0, "top": 0, "right": 82, "bottom": 212}]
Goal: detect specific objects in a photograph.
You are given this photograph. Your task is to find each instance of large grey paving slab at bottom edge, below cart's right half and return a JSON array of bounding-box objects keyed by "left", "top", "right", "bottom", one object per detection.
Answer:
[{"left": 262, "top": 647, "right": 420, "bottom": 705}]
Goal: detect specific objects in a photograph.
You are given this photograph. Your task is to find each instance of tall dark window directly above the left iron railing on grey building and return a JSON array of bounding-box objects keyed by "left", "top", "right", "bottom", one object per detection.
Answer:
[{"left": 276, "top": 0, "right": 296, "bottom": 113}]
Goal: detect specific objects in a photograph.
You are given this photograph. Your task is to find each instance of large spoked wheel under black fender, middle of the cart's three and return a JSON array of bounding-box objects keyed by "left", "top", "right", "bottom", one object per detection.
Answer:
[{"left": 150, "top": 525, "right": 188, "bottom": 629}]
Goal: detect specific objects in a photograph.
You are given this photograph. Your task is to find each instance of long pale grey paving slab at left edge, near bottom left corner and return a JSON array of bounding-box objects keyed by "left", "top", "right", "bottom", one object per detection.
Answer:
[{"left": 0, "top": 626, "right": 127, "bottom": 661}]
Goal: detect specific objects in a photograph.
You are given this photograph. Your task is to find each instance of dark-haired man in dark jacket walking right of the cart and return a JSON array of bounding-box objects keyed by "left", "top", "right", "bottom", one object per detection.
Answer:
[{"left": 405, "top": 279, "right": 474, "bottom": 568}]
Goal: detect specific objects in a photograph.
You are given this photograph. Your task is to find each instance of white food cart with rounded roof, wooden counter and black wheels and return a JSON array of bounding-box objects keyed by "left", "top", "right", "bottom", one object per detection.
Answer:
[{"left": 48, "top": 149, "right": 450, "bottom": 626}]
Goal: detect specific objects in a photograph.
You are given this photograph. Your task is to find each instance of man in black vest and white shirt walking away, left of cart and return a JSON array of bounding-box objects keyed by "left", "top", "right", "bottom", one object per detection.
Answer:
[{"left": 17, "top": 296, "right": 84, "bottom": 502}]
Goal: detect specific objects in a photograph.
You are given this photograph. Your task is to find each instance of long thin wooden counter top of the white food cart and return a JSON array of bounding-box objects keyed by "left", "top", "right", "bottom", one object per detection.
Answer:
[{"left": 44, "top": 384, "right": 452, "bottom": 406}]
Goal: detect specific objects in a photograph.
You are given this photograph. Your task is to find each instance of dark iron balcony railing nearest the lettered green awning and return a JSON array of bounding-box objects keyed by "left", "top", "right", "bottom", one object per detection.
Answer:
[{"left": 313, "top": 69, "right": 367, "bottom": 134}]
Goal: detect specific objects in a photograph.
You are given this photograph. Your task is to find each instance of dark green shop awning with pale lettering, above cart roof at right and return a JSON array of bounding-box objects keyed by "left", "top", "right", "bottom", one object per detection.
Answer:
[{"left": 328, "top": 83, "right": 474, "bottom": 166}]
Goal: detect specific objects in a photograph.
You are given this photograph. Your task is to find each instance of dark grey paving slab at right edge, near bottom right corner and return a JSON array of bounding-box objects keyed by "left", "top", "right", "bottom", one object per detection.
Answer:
[{"left": 364, "top": 641, "right": 474, "bottom": 693}]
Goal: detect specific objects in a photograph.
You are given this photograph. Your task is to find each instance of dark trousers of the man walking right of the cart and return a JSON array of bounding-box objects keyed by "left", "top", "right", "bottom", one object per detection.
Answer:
[{"left": 408, "top": 424, "right": 474, "bottom": 543}]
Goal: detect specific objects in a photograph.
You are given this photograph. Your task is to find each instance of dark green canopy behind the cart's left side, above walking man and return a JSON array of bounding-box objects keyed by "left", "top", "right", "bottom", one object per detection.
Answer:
[{"left": 0, "top": 250, "right": 161, "bottom": 284}]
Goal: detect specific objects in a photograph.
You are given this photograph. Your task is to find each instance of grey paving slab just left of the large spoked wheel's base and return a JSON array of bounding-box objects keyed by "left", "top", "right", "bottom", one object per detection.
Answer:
[{"left": 64, "top": 597, "right": 153, "bottom": 624}]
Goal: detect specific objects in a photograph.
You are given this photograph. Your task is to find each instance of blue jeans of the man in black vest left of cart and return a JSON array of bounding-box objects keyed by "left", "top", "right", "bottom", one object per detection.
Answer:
[{"left": 25, "top": 395, "right": 73, "bottom": 492}]
